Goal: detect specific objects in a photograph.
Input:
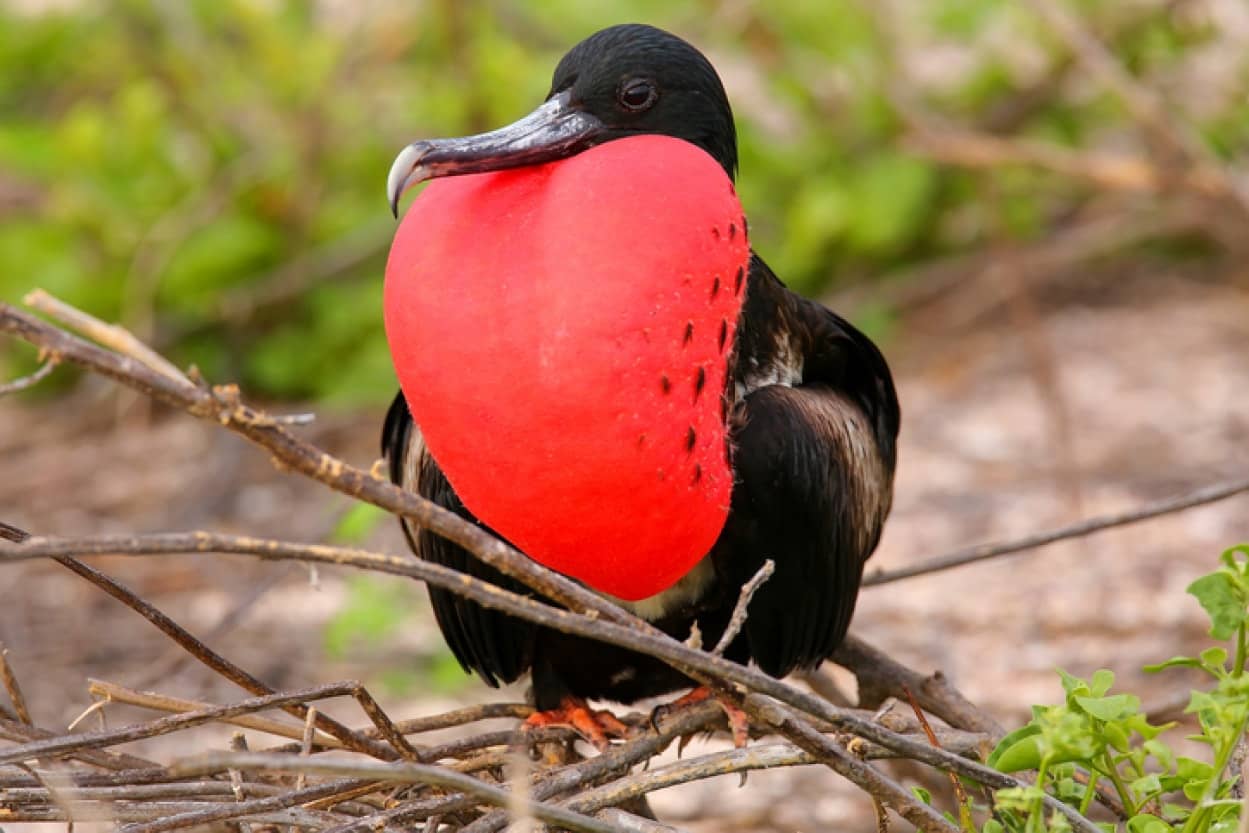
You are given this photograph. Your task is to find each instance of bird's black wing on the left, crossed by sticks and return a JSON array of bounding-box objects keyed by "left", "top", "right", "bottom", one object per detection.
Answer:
[{"left": 382, "top": 392, "right": 535, "bottom": 687}]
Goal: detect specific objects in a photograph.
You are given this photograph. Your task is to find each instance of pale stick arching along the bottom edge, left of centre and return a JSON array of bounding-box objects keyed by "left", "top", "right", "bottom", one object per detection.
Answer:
[{"left": 171, "top": 752, "right": 622, "bottom": 833}]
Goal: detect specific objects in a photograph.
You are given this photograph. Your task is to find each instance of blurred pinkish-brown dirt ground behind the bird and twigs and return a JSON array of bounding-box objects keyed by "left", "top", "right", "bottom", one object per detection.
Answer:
[{"left": 0, "top": 281, "right": 1249, "bottom": 833}]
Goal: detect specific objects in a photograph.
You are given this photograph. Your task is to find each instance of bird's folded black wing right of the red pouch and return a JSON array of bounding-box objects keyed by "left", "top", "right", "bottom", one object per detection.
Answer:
[{"left": 713, "top": 261, "right": 899, "bottom": 676}]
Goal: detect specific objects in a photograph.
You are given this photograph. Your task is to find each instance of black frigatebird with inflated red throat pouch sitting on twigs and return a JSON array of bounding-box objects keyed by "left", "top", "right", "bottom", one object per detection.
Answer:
[{"left": 382, "top": 24, "right": 901, "bottom": 744}]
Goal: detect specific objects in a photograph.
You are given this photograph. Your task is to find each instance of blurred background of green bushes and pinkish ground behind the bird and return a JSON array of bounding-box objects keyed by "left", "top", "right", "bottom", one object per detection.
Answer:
[{"left": 0, "top": 0, "right": 1249, "bottom": 831}]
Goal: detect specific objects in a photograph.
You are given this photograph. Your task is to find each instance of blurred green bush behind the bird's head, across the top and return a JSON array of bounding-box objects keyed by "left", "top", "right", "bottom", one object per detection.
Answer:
[{"left": 0, "top": 0, "right": 1249, "bottom": 405}]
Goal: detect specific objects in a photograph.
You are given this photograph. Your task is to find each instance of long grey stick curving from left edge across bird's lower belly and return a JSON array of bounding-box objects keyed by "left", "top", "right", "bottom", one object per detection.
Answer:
[{"left": 0, "top": 532, "right": 1095, "bottom": 833}]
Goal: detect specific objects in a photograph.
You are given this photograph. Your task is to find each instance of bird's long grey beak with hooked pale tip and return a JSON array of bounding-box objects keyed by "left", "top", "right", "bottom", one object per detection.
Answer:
[{"left": 386, "top": 91, "right": 606, "bottom": 217}]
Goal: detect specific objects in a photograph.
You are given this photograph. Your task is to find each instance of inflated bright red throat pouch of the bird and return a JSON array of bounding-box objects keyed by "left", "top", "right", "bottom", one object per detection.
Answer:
[{"left": 385, "top": 136, "right": 749, "bottom": 599}]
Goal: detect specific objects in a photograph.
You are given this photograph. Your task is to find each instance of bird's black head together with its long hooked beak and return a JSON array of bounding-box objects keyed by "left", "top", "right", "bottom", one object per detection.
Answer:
[{"left": 386, "top": 24, "right": 737, "bottom": 210}]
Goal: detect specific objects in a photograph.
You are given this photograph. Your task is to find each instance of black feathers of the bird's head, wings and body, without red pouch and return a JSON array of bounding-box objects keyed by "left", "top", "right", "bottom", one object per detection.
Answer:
[{"left": 382, "top": 25, "right": 899, "bottom": 709}]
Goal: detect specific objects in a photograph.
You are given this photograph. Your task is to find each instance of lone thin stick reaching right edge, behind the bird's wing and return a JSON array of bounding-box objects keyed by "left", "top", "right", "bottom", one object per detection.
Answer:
[{"left": 863, "top": 477, "right": 1249, "bottom": 587}]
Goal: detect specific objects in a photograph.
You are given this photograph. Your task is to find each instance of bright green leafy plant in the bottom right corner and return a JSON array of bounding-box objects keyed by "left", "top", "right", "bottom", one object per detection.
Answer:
[{"left": 984, "top": 546, "right": 1249, "bottom": 833}]
